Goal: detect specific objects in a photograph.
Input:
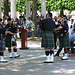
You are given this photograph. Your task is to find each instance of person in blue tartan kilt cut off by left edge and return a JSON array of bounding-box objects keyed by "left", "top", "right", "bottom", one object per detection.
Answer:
[{"left": 0, "top": 18, "right": 7, "bottom": 62}]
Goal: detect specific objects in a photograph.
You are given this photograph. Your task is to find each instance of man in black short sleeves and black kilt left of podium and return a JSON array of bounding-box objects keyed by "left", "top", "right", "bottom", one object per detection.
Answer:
[{"left": 5, "top": 18, "right": 20, "bottom": 58}]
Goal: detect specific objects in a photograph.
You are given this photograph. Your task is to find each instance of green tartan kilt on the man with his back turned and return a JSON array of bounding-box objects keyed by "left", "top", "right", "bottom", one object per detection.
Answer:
[{"left": 41, "top": 32, "right": 55, "bottom": 48}]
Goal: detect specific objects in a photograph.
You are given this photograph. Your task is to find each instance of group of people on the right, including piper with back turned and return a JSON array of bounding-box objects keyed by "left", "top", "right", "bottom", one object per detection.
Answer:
[{"left": 38, "top": 13, "right": 75, "bottom": 63}]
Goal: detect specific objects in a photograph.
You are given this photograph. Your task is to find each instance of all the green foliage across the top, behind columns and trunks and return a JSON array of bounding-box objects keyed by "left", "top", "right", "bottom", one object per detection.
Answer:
[{"left": 1, "top": 0, "right": 75, "bottom": 12}]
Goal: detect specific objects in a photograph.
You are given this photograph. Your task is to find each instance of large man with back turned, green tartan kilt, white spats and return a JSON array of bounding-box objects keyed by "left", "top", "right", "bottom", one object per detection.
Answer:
[{"left": 40, "top": 13, "right": 55, "bottom": 63}]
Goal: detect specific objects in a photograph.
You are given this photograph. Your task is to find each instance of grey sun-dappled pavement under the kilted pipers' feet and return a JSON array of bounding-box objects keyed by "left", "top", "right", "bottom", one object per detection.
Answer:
[{"left": 0, "top": 42, "right": 75, "bottom": 75}]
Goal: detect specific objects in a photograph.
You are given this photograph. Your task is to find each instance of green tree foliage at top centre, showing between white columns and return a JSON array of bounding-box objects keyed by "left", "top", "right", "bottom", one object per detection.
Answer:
[{"left": 16, "top": 0, "right": 41, "bottom": 13}]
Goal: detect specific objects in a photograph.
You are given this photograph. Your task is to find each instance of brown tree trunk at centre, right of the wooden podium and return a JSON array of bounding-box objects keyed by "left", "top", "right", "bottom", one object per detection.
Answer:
[{"left": 32, "top": 0, "right": 37, "bottom": 36}]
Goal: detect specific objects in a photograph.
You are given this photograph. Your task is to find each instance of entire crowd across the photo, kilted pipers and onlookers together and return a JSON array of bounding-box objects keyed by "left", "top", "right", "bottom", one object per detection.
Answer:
[{"left": 0, "top": 13, "right": 75, "bottom": 63}]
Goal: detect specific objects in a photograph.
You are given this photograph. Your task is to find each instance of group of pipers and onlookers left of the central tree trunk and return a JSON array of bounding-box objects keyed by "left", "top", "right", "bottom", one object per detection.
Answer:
[{"left": 0, "top": 15, "right": 38, "bottom": 62}]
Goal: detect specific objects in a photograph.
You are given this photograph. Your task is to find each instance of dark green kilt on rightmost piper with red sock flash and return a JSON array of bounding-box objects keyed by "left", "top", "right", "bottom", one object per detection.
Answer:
[{"left": 59, "top": 34, "right": 71, "bottom": 48}]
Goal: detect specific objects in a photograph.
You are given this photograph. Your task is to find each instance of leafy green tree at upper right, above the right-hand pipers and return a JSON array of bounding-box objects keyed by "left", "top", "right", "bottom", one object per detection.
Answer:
[{"left": 47, "top": 0, "right": 75, "bottom": 15}]
